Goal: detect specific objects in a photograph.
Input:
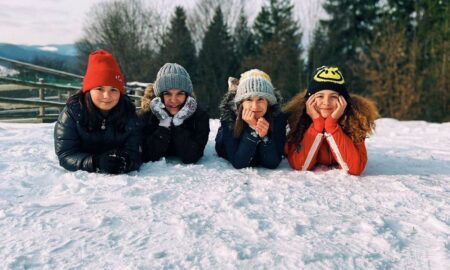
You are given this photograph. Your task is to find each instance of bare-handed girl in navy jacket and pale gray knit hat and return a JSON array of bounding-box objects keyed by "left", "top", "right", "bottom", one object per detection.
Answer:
[{"left": 216, "top": 69, "right": 286, "bottom": 169}]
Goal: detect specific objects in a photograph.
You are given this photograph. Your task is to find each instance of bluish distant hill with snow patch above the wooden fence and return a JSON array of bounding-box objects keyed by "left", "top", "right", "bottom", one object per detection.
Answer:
[{"left": 0, "top": 43, "right": 79, "bottom": 73}]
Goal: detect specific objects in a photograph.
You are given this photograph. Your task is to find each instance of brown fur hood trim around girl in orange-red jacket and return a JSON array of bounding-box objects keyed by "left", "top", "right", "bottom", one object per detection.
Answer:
[{"left": 283, "top": 91, "right": 379, "bottom": 142}]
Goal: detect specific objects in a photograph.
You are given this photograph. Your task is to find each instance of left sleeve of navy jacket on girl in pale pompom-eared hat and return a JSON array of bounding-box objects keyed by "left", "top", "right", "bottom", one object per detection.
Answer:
[{"left": 216, "top": 122, "right": 261, "bottom": 169}]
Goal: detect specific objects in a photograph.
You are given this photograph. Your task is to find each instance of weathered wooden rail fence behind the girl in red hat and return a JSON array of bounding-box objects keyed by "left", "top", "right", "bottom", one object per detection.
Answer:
[{"left": 0, "top": 57, "right": 145, "bottom": 122}]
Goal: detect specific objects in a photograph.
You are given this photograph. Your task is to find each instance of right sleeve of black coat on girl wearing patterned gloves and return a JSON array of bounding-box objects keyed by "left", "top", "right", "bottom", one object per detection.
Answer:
[{"left": 172, "top": 112, "right": 209, "bottom": 164}]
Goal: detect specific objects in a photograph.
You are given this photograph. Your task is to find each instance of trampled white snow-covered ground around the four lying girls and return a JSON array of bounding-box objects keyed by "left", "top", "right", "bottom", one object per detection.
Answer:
[{"left": 0, "top": 119, "right": 450, "bottom": 270}]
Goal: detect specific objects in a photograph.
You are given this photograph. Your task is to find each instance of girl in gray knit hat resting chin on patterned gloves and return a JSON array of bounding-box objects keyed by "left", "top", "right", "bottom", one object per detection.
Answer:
[{"left": 140, "top": 63, "right": 209, "bottom": 163}]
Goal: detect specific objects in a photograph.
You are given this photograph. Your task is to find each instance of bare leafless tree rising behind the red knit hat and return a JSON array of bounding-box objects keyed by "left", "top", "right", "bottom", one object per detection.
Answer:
[{"left": 77, "top": 0, "right": 162, "bottom": 81}]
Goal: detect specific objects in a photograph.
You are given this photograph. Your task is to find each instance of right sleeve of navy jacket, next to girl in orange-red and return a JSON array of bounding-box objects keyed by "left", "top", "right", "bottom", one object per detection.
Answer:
[{"left": 258, "top": 114, "right": 286, "bottom": 169}]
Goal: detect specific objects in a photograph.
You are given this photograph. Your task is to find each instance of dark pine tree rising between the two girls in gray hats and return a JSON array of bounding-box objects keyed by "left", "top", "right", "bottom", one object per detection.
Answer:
[{"left": 196, "top": 7, "right": 236, "bottom": 117}]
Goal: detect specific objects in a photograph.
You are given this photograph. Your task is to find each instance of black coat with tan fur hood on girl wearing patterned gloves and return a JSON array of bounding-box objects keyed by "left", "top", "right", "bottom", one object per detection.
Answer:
[{"left": 139, "top": 86, "right": 209, "bottom": 164}]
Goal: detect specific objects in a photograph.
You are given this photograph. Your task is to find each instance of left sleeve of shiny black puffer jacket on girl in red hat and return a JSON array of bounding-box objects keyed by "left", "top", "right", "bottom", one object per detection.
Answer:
[{"left": 53, "top": 107, "right": 95, "bottom": 172}]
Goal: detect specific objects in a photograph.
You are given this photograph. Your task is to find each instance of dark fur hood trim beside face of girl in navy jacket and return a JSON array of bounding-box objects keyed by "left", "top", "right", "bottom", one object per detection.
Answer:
[{"left": 219, "top": 83, "right": 283, "bottom": 128}]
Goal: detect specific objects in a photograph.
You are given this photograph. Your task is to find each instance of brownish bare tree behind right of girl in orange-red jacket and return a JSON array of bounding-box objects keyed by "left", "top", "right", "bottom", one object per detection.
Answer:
[{"left": 352, "top": 22, "right": 422, "bottom": 120}]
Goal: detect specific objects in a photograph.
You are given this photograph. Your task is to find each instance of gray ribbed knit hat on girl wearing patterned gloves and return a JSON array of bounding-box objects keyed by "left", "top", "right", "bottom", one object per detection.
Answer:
[{"left": 154, "top": 63, "right": 193, "bottom": 96}]
